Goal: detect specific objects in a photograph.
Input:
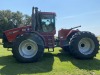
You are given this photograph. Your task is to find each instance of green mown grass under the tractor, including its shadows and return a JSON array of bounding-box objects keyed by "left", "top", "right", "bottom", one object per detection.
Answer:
[{"left": 0, "top": 38, "right": 100, "bottom": 75}]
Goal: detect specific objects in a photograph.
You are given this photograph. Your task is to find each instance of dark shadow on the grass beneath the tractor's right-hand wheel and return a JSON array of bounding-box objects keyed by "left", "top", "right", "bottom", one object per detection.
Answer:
[{"left": 57, "top": 50, "right": 100, "bottom": 70}]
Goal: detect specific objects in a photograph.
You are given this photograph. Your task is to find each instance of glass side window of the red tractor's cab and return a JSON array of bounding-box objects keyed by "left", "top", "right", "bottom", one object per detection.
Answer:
[{"left": 41, "top": 14, "right": 55, "bottom": 32}]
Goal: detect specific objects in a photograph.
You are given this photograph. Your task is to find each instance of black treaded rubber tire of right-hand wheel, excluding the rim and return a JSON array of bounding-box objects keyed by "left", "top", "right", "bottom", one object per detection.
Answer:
[{"left": 70, "top": 31, "right": 99, "bottom": 59}]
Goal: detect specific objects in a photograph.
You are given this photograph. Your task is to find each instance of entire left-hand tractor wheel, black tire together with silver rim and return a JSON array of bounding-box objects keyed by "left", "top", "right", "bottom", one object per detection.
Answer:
[{"left": 12, "top": 33, "right": 44, "bottom": 63}]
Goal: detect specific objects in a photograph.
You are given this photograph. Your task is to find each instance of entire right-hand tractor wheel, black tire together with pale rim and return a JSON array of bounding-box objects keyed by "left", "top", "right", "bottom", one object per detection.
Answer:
[{"left": 70, "top": 32, "right": 99, "bottom": 59}]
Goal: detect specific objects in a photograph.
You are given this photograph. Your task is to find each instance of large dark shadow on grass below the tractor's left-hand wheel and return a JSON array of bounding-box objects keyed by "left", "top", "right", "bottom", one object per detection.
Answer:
[{"left": 0, "top": 53, "right": 54, "bottom": 75}]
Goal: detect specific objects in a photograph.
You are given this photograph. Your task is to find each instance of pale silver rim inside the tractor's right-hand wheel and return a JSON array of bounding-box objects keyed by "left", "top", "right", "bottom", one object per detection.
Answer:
[{"left": 78, "top": 38, "right": 95, "bottom": 55}]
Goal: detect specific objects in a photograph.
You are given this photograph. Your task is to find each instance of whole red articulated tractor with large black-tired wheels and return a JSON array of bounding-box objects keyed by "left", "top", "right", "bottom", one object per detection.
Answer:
[{"left": 3, "top": 7, "right": 99, "bottom": 62}]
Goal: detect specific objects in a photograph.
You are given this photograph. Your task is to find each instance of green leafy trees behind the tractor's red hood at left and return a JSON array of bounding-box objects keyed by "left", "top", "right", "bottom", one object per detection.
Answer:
[{"left": 0, "top": 10, "right": 31, "bottom": 35}]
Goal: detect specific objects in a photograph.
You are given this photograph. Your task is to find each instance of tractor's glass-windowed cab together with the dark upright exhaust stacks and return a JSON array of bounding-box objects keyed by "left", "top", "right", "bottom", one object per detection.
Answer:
[{"left": 32, "top": 7, "right": 56, "bottom": 33}]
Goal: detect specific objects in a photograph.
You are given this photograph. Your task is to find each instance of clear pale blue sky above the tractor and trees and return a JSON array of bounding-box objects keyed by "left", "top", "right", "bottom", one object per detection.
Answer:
[{"left": 0, "top": 0, "right": 100, "bottom": 35}]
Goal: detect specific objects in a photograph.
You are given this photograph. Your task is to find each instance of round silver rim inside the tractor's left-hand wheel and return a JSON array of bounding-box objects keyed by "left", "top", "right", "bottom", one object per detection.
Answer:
[{"left": 19, "top": 39, "right": 38, "bottom": 58}]
